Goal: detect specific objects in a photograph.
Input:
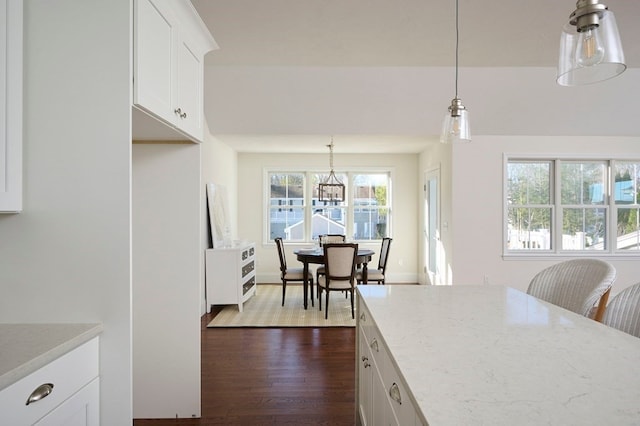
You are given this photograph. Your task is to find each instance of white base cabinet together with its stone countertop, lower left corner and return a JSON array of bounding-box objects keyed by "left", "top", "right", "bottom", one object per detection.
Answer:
[{"left": 0, "top": 324, "right": 101, "bottom": 426}]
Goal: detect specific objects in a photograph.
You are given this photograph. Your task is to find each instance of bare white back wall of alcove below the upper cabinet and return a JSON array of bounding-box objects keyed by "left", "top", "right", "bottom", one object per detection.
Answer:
[{"left": 132, "top": 142, "right": 203, "bottom": 418}]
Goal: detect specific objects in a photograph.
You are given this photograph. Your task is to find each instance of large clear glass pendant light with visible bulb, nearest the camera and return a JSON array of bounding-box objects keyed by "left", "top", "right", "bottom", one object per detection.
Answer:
[{"left": 557, "top": 0, "right": 627, "bottom": 86}]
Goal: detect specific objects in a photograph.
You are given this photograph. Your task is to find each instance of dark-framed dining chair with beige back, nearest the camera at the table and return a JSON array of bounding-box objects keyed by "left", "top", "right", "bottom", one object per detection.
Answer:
[{"left": 318, "top": 243, "right": 358, "bottom": 319}]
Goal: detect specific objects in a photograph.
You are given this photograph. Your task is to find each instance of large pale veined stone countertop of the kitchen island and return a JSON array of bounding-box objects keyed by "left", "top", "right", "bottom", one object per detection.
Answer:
[{"left": 358, "top": 285, "right": 640, "bottom": 426}]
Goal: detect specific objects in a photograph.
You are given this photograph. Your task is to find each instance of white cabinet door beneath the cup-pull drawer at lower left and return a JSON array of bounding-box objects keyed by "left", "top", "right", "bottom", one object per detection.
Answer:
[{"left": 35, "top": 378, "right": 100, "bottom": 426}]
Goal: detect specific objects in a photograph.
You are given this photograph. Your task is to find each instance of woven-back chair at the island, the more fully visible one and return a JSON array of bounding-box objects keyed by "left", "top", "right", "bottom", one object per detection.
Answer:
[{"left": 527, "top": 259, "right": 616, "bottom": 321}]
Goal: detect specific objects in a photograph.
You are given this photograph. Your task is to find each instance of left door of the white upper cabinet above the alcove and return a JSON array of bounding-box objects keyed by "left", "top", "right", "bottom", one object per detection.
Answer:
[{"left": 133, "top": 0, "right": 175, "bottom": 123}]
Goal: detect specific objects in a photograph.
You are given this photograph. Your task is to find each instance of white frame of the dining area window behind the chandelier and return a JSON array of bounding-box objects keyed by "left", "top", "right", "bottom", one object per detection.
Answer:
[{"left": 262, "top": 167, "right": 395, "bottom": 245}]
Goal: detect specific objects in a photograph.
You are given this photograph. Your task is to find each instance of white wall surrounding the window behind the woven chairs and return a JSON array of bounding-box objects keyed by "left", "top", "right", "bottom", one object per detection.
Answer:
[{"left": 452, "top": 136, "right": 640, "bottom": 294}]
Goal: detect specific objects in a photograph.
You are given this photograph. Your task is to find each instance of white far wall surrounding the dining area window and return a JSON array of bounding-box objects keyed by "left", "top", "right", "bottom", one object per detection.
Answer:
[{"left": 238, "top": 153, "right": 421, "bottom": 283}]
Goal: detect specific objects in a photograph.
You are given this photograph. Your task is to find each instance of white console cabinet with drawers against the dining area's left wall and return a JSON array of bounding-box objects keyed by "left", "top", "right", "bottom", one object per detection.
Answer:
[{"left": 205, "top": 243, "right": 256, "bottom": 312}]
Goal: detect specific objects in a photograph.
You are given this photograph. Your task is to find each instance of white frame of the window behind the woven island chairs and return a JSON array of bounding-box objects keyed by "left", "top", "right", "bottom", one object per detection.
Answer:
[{"left": 502, "top": 153, "right": 640, "bottom": 259}]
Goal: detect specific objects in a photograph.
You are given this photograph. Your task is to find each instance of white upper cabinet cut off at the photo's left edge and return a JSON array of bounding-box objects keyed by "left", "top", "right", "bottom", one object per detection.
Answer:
[{"left": 0, "top": 0, "right": 23, "bottom": 213}]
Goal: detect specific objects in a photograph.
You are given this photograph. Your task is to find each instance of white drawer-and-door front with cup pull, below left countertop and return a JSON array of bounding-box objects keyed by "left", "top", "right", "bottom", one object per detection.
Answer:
[{"left": 0, "top": 337, "right": 100, "bottom": 426}]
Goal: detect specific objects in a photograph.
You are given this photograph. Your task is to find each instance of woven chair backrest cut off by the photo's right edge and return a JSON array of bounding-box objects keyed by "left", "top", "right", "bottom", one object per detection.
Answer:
[{"left": 602, "top": 283, "right": 640, "bottom": 337}]
